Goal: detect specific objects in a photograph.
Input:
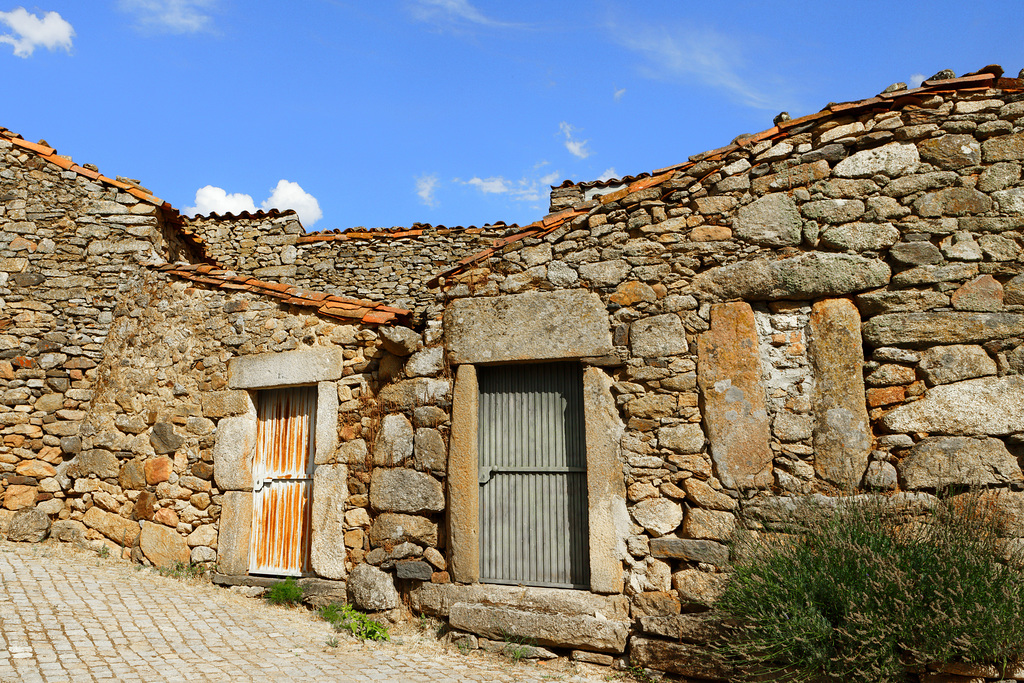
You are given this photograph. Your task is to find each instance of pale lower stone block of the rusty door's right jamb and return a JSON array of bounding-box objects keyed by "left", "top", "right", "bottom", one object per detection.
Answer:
[{"left": 309, "top": 465, "right": 348, "bottom": 579}]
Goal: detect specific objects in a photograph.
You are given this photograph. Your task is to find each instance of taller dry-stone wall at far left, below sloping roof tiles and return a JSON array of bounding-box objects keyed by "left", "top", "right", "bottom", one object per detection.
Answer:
[{"left": 0, "top": 139, "right": 180, "bottom": 516}]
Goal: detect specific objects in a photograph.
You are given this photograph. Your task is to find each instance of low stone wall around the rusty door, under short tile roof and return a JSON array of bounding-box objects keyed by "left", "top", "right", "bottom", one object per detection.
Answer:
[{"left": 69, "top": 272, "right": 450, "bottom": 581}]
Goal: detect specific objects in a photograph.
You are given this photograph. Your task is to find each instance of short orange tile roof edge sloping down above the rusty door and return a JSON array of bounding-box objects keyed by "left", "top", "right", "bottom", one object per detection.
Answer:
[{"left": 154, "top": 263, "right": 412, "bottom": 325}]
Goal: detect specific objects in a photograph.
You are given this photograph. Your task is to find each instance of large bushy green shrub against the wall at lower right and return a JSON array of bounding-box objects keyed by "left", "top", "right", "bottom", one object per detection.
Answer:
[{"left": 718, "top": 493, "right": 1024, "bottom": 683}]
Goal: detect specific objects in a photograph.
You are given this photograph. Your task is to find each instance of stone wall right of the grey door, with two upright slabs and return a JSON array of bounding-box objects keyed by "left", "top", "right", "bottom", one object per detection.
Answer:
[{"left": 434, "top": 81, "right": 1024, "bottom": 678}]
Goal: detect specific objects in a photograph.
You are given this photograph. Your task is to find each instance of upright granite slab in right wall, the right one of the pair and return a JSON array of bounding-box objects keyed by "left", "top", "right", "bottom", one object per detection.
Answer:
[{"left": 809, "top": 299, "right": 871, "bottom": 488}]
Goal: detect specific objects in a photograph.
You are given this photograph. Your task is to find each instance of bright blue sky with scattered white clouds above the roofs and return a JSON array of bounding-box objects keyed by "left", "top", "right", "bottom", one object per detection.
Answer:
[{"left": 0, "top": 0, "right": 1024, "bottom": 230}]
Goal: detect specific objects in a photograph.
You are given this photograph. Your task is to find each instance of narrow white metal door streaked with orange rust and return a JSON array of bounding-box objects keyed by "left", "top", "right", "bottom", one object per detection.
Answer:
[{"left": 249, "top": 387, "right": 316, "bottom": 575}]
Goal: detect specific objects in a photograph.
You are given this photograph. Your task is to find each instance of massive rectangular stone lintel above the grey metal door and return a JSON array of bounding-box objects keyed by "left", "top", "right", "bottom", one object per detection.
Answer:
[{"left": 444, "top": 290, "right": 613, "bottom": 365}]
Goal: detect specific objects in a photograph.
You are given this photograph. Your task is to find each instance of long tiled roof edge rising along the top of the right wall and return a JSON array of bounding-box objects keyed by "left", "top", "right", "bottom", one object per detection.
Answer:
[{"left": 436, "top": 66, "right": 1024, "bottom": 286}]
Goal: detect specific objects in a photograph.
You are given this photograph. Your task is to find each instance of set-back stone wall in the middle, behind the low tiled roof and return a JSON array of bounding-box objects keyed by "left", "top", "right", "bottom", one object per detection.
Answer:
[{"left": 186, "top": 211, "right": 503, "bottom": 322}]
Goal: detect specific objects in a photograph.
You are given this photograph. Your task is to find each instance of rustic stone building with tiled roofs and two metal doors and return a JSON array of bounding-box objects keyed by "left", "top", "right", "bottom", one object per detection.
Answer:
[{"left": 0, "top": 69, "right": 1024, "bottom": 679}]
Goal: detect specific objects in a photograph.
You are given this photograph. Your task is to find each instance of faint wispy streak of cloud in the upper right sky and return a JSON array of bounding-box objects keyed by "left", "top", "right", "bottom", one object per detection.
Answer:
[{"left": 609, "top": 22, "right": 793, "bottom": 112}]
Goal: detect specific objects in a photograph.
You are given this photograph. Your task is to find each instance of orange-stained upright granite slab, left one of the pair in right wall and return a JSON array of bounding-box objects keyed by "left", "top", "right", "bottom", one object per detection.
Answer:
[{"left": 697, "top": 302, "right": 772, "bottom": 488}]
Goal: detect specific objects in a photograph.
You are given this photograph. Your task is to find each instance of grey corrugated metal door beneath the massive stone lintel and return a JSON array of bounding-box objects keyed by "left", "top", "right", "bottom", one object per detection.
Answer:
[{"left": 478, "top": 362, "right": 590, "bottom": 588}]
